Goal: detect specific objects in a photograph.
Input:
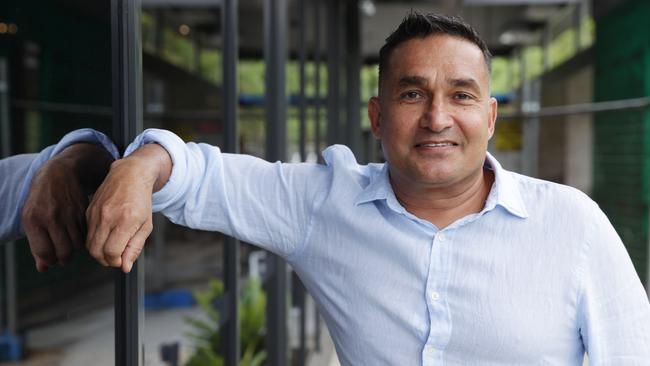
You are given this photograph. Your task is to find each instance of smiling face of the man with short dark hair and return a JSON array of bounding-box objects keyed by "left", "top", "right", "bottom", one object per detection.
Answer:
[{"left": 368, "top": 35, "right": 497, "bottom": 192}]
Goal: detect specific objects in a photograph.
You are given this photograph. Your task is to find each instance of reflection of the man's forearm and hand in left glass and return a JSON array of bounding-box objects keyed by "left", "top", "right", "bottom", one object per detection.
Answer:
[{"left": 0, "top": 128, "right": 119, "bottom": 272}]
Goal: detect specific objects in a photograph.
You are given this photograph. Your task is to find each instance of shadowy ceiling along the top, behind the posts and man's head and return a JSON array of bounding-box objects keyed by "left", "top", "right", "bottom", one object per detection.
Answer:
[{"left": 57, "top": 0, "right": 624, "bottom": 61}]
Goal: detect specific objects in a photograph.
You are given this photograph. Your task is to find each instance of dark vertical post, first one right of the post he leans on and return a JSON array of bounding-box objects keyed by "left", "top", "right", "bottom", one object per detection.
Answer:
[{"left": 221, "top": 0, "right": 241, "bottom": 366}]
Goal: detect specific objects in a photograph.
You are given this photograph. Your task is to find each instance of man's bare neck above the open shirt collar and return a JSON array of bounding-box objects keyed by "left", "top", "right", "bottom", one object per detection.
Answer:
[{"left": 391, "top": 168, "right": 494, "bottom": 229}]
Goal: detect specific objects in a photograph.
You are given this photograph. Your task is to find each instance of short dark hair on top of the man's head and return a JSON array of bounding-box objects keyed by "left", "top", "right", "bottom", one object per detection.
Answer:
[{"left": 379, "top": 11, "right": 492, "bottom": 89}]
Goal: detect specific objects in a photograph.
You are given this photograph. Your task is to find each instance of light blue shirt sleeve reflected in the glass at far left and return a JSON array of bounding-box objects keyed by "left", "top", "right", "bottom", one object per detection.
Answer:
[{"left": 0, "top": 128, "right": 119, "bottom": 242}]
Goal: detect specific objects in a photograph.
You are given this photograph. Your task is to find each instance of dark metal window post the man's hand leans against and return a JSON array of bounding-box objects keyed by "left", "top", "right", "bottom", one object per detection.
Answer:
[{"left": 111, "top": 0, "right": 144, "bottom": 366}]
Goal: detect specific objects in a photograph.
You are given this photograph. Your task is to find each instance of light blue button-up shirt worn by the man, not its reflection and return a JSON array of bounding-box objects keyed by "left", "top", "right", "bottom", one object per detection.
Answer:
[{"left": 127, "top": 130, "right": 650, "bottom": 366}]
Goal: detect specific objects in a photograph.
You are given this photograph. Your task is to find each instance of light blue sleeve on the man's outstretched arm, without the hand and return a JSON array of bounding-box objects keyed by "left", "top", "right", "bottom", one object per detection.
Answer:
[{"left": 125, "top": 129, "right": 329, "bottom": 258}]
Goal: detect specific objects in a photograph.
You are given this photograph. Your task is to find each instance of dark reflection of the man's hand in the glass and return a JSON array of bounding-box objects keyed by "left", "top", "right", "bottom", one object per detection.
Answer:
[{"left": 22, "top": 143, "right": 113, "bottom": 272}]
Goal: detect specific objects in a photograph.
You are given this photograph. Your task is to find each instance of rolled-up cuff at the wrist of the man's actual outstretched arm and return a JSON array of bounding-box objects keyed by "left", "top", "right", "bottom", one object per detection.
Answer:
[{"left": 124, "top": 128, "right": 187, "bottom": 212}]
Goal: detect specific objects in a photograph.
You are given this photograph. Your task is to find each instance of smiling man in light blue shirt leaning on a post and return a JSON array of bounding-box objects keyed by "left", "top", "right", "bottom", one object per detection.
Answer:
[{"left": 86, "top": 13, "right": 650, "bottom": 365}]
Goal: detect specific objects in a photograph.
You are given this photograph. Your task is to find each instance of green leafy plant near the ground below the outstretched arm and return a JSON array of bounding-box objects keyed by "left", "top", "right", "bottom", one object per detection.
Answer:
[{"left": 185, "top": 279, "right": 266, "bottom": 366}]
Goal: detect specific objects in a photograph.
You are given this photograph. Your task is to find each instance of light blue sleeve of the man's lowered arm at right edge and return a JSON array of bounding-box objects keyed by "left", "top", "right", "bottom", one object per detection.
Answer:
[{"left": 579, "top": 203, "right": 650, "bottom": 366}]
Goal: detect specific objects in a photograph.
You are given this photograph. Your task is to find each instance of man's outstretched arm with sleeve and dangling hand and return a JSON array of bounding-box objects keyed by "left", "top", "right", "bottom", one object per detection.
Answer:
[{"left": 86, "top": 129, "right": 331, "bottom": 272}]
